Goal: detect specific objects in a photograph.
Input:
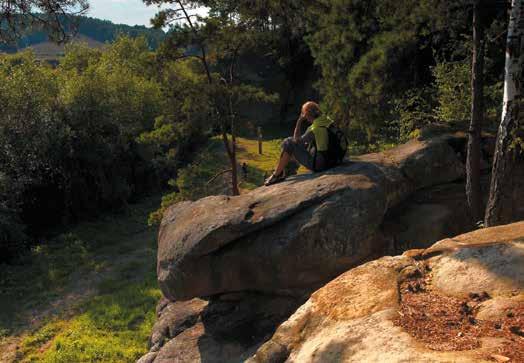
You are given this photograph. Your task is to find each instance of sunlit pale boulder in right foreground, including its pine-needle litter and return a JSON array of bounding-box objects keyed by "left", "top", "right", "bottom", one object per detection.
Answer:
[{"left": 250, "top": 222, "right": 524, "bottom": 363}]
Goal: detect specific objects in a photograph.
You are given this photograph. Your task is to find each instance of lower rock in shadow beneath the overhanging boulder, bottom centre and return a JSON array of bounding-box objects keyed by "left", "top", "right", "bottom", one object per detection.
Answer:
[{"left": 139, "top": 294, "right": 303, "bottom": 363}]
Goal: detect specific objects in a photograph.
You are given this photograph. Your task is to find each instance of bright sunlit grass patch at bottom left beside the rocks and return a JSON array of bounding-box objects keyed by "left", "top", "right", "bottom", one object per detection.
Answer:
[{"left": 21, "top": 271, "right": 161, "bottom": 363}]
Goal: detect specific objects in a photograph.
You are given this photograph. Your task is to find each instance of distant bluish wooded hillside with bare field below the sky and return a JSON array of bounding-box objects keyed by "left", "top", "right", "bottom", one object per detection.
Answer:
[{"left": 0, "top": 16, "right": 165, "bottom": 59}]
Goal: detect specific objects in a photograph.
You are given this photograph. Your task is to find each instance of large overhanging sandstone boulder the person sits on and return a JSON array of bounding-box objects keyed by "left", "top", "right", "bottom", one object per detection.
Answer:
[{"left": 157, "top": 137, "right": 464, "bottom": 300}]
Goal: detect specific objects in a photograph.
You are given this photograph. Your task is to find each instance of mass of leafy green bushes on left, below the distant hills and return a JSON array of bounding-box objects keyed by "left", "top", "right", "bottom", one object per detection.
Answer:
[{"left": 0, "top": 37, "right": 181, "bottom": 260}]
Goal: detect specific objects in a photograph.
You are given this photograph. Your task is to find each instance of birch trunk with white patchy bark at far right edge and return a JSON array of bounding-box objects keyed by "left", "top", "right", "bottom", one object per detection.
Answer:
[{"left": 485, "top": 0, "right": 524, "bottom": 227}]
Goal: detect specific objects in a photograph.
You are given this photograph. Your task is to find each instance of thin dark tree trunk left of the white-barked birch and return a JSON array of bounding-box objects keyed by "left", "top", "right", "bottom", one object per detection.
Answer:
[{"left": 466, "top": 0, "right": 484, "bottom": 223}]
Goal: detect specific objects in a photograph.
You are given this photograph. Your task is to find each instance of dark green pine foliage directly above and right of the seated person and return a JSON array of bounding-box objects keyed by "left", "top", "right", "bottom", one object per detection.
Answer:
[{"left": 306, "top": 0, "right": 438, "bottom": 130}]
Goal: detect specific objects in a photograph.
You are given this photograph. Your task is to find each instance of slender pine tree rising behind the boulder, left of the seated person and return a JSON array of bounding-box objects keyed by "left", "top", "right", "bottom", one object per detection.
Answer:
[{"left": 144, "top": 0, "right": 273, "bottom": 195}]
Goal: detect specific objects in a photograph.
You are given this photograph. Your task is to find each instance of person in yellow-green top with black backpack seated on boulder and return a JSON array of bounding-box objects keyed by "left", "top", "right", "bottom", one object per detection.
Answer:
[{"left": 264, "top": 101, "right": 332, "bottom": 186}]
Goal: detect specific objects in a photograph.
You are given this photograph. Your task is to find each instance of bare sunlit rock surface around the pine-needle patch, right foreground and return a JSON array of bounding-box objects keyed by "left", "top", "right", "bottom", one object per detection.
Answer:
[{"left": 250, "top": 222, "right": 524, "bottom": 363}]
